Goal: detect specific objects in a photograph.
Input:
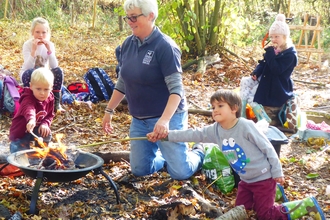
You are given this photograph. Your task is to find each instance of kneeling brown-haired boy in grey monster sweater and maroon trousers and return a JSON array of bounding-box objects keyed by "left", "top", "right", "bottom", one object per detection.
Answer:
[{"left": 147, "top": 90, "right": 323, "bottom": 219}]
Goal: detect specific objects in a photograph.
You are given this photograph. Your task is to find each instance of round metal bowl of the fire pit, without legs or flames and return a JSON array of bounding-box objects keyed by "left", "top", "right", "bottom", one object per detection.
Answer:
[{"left": 7, "top": 149, "right": 104, "bottom": 182}]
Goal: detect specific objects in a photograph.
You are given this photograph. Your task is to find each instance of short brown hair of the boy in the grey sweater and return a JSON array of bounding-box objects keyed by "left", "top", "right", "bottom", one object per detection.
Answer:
[{"left": 210, "top": 89, "right": 242, "bottom": 118}]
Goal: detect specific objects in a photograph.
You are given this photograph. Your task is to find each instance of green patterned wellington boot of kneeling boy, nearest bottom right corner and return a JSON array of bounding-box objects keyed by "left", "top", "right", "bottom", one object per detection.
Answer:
[{"left": 281, "top": 196, "right": 325, "bottom": 220}]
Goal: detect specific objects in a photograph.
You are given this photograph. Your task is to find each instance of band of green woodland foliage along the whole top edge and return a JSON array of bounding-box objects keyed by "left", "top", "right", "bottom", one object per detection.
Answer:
[{"left": 0, "top": 0, "right": 330, "bottom": 57}]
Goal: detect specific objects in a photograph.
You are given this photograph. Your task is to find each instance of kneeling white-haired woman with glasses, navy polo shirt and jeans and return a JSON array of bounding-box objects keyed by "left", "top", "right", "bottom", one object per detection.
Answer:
[{"left": 102, "top": 0, "right": 204, "bottom": 180}]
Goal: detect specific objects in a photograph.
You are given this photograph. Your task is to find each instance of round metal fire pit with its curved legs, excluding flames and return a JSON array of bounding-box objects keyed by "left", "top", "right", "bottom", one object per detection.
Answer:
[{"left": 7, "top": 149, "right": 120, "bottom": 214}]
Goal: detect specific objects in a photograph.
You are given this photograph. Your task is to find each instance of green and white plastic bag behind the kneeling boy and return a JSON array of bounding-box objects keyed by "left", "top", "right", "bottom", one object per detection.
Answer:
[{"left": 202, "top": 144, "right": 235, "bottom": 194}]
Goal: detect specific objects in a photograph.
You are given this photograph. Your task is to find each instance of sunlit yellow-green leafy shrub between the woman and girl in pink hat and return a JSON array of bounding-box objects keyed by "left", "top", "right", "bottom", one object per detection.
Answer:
[{"left": 157, "top": 0, "right": 276, "bottom": 56}]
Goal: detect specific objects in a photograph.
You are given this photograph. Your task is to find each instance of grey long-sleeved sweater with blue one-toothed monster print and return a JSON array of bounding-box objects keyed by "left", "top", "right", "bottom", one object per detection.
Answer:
[{"left": 168, "top": 118, "right": 283, "bottom": 183}]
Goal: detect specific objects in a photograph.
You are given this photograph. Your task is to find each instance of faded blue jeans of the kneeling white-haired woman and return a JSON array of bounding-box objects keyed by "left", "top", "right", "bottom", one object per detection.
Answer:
[{"left": 130, "top": 112, "right": 204, "bottom": 180}]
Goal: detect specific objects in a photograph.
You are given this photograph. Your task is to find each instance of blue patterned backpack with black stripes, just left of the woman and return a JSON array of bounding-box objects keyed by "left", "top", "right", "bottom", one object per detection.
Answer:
[{"left": 84, "top": 68, "right": 115, "bottom": 103}]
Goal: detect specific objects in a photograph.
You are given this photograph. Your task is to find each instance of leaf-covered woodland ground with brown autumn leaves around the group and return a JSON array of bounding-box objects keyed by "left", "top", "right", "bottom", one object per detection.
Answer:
[{"left": 0, "top": 21, "right": 330, "bottom": 219}]
